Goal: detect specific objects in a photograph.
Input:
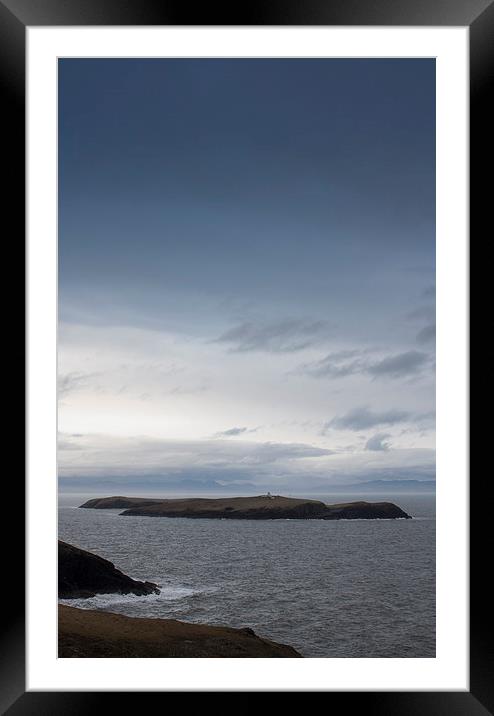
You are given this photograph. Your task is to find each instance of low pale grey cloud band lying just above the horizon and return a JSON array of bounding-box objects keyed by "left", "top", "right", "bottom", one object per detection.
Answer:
[{"left": 59, "top": 434, "right": 435, "bottom": 491}]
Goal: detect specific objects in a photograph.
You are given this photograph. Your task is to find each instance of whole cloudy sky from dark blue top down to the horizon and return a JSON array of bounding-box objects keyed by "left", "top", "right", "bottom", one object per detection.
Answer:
[{"left": 58, "top": 59, "right": 435, "bottom": 493}]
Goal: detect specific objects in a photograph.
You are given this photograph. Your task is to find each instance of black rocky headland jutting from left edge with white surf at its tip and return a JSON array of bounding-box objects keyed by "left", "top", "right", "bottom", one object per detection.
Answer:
[{"left": 58, "top": 540, "right": 160, "bottom": 599}]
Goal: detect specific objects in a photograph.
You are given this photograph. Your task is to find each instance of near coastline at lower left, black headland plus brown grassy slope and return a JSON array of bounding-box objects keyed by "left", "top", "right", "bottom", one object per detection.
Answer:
[{"left": 58, "top": 540, "right": 301, "bottom": 658}]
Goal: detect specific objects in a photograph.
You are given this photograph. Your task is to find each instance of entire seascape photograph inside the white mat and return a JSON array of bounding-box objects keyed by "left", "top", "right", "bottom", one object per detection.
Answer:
[{"left": 57, "top": 56, "right": 437, "bottom": 660}]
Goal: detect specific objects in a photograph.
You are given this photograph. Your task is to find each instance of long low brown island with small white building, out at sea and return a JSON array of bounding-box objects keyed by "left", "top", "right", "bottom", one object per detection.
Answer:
[{"left": 80, "top": 493, "right": 411, "bottom": 520}]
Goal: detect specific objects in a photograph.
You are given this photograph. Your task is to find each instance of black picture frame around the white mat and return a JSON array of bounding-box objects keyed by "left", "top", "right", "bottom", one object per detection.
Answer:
[{"left": 5, "top": 0, "right": 486, "bottom": 716}]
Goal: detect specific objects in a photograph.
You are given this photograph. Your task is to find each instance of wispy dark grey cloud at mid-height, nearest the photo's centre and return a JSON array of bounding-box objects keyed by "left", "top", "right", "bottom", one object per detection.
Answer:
[{"left": 213, "top": 318, "right": 327, "bottom": 353}]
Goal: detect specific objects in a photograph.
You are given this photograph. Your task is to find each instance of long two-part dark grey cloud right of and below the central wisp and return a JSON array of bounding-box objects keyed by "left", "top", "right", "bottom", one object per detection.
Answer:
[{"left": 298, "top": 350, "right": 429, "bottom": 378}]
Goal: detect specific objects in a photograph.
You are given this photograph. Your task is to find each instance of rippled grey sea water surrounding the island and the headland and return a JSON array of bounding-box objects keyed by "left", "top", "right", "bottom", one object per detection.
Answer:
[{"left": 59, "top": 494, "right": 435, "bottom": 658}]
